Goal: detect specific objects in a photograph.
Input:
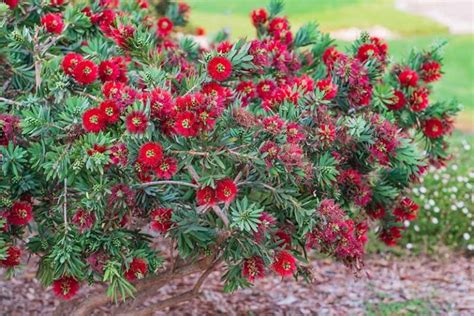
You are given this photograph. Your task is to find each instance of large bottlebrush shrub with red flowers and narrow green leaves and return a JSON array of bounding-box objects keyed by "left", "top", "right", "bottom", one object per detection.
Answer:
[{"left": 0, "top": 0, "right": 459, "bottom": 313}]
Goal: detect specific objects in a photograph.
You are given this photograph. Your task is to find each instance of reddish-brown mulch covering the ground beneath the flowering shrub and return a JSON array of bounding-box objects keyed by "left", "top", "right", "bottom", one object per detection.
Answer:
[{"left": 0, "top": 254, "right": 474, "bottom": 316}]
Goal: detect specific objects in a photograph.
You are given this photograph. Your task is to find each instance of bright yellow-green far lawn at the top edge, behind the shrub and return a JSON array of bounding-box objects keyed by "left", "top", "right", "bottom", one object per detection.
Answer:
[{"left": 188, "top": 0, "right": 448, "bottom": 38}]
